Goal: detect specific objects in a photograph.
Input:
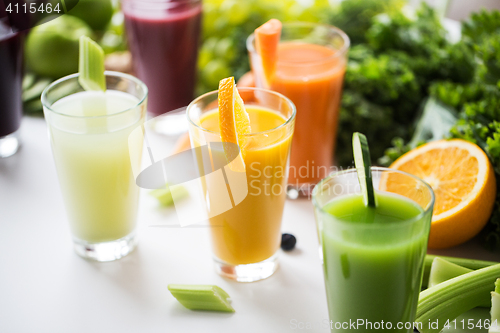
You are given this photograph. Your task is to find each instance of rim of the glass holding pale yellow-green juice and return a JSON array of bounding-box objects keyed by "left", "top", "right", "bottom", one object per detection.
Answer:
[{"left": 41, "top": 71, "right": 149, "bottom": 119}]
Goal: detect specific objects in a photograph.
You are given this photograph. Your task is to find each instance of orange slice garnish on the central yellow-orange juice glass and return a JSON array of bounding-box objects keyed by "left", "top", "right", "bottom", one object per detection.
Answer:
[{"left": 219, "top": 77, "right": 251, "bottom": 170}]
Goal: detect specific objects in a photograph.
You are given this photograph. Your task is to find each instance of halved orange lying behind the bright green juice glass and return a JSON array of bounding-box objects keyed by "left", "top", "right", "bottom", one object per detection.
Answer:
[{"left": 380, "top": 139, "right": 496, "bottom": 249}]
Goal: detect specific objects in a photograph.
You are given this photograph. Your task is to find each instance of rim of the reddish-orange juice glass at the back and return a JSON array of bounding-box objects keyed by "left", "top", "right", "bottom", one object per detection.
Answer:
[{"left": 246, "top": 21, "right": 351, "bottom": 66}]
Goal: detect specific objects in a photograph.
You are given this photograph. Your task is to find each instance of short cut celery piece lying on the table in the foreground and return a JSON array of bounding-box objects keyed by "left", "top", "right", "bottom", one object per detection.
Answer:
[{"left": 168, "top": 284, "right": 234, "bottom": 312}]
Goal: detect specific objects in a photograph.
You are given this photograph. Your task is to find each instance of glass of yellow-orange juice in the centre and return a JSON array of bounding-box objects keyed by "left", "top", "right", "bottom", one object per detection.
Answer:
[{"left": 187, "top": 88, "right": 296, "bottom": 282}]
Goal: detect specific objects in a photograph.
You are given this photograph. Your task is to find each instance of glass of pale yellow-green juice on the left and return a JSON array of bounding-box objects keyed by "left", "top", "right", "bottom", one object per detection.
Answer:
[{"left": 42, "top": 72, "right": 148, "bottom": 261}]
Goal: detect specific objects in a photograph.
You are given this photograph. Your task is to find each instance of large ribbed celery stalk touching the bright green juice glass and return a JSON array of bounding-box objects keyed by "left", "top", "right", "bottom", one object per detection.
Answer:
[{"left": 416, "top": 264, "right": 500, "bottom": 333}]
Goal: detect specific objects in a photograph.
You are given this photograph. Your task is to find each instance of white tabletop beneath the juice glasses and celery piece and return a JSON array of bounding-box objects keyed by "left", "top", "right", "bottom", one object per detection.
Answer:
[{"left": 0, "top": 117, "right": 500, "bottom": 333}]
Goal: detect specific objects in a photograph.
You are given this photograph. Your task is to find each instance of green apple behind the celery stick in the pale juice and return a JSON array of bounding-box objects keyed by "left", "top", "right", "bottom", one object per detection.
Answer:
[{"left": 25, "top": 15, "right": 92, "bottom": 78}]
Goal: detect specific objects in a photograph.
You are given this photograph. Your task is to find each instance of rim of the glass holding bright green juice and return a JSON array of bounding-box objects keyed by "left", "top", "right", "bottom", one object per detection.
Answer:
[{"left": 312, "top": 166, "right": 436, "bottom": 229}]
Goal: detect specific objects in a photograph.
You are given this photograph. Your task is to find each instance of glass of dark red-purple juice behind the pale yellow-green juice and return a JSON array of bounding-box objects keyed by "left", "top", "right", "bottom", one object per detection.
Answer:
[{"left": 122, "top": 0, "right": 202, "bottom": 116}]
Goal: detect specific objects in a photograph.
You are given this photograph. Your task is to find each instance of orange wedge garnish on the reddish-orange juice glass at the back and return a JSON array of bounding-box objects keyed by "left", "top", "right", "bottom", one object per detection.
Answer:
[{"left": 255, "top": 19, "right": 282, "bottom": 87}]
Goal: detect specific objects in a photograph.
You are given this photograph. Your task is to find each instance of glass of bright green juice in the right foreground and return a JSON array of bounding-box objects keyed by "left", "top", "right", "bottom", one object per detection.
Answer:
[{"left": 313, "top": 167, "right": 434, "bottom": 332}]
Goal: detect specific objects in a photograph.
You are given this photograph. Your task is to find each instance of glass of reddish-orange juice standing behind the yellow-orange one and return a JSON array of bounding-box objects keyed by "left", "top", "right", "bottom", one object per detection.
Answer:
[{"left": 247, "top": 22, "right": 350, "bottom": 198}]
